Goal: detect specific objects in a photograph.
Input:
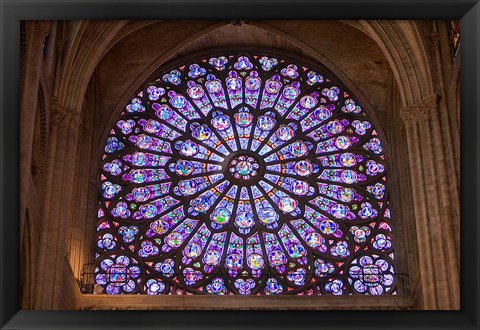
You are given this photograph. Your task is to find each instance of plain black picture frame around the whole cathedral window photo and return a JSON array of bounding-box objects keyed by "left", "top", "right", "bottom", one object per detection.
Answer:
[{"left": 0, "top": 0, "right": 480, "bottom": 329}]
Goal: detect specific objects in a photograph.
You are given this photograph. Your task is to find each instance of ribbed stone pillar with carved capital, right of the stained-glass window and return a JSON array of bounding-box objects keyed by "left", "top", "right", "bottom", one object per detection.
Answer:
[{"left": 401, "top": 95, "right": 460, "bottom": 309}]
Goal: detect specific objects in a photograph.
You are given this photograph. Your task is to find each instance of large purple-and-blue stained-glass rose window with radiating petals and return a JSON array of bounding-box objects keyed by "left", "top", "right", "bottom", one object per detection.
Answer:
[{"left": 95, "top": 53, "right": 395, "bottom": 295}]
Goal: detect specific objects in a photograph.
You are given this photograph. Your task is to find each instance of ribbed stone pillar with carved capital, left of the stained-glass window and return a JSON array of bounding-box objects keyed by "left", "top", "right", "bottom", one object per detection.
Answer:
[{"left": 34, "top": 100, "right": 80, "bottom": 309}]
